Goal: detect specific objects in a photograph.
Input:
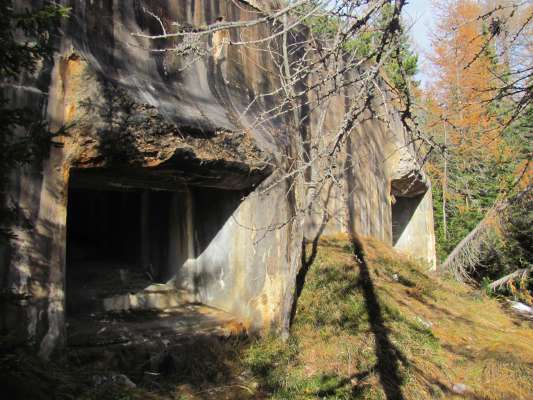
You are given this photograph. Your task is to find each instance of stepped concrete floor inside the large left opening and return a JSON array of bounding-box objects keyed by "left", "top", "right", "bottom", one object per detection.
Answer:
[{"left": 67, "top": 261, "right": 245, "bottom": 348}]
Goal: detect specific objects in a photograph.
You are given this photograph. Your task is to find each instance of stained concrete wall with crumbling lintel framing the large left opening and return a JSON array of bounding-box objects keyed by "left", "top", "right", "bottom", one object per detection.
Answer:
[{"left": 1, "top": 1, "right": 302, "bottom": 357}]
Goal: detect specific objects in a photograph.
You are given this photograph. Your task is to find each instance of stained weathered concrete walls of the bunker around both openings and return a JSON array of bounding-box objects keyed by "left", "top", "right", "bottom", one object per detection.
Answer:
[{"left": 0, "top": 0, "right": 434, "bottom": 357}]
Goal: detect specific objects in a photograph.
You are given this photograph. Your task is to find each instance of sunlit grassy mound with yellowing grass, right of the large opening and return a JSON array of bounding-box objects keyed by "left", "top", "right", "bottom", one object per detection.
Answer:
[{"left": 247, "top": 234, "right": 533, "bottom": 399}]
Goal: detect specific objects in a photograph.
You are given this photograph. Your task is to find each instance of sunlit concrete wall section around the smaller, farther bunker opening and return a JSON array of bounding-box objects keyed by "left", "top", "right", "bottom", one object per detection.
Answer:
[{"left": 305, "top": 70, "right": 436, "bottom": 268}]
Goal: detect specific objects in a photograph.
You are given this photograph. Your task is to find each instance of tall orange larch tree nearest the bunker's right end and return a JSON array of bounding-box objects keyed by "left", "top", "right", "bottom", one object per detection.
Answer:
[{"left": 425, "top": 0, "right": 512, "bottom": 256}]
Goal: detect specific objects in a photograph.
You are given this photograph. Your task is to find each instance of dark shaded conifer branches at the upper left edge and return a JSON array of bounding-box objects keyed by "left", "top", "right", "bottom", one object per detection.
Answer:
[{"left": 0, "top": 0, "right": 69, "bottom": 236}]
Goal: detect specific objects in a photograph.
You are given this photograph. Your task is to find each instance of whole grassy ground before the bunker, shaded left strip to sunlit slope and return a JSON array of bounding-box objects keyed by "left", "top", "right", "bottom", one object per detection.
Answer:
[{"left": 0, "top": 237, "right": 533, "bottom": 400}]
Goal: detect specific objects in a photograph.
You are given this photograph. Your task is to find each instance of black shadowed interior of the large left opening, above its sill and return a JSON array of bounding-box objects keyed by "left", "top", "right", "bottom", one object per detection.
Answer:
[{"left": 66, "top": 187, "right": 243, "bottom": 316}]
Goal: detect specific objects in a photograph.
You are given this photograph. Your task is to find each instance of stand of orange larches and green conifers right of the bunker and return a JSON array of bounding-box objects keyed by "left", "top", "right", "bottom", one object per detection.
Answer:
[{"left": 421, "top": 0, "right": 533, "bottom": 301}]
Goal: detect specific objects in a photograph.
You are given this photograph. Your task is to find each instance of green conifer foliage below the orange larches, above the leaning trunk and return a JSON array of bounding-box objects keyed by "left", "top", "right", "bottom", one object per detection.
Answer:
[{"left": 432, "top": 96, "right": 533, "bottom": 261}]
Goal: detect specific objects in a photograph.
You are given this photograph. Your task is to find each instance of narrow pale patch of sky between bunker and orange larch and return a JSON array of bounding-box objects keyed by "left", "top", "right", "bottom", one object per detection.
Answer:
[{"left": 405, "top": 0, "right": 434, "bottom": 85}]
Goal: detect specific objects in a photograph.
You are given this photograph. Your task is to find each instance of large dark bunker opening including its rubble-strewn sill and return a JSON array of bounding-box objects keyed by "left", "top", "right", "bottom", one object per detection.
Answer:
[{"left": 65, "top": 168, "right": 245, "bottom": 344}]
